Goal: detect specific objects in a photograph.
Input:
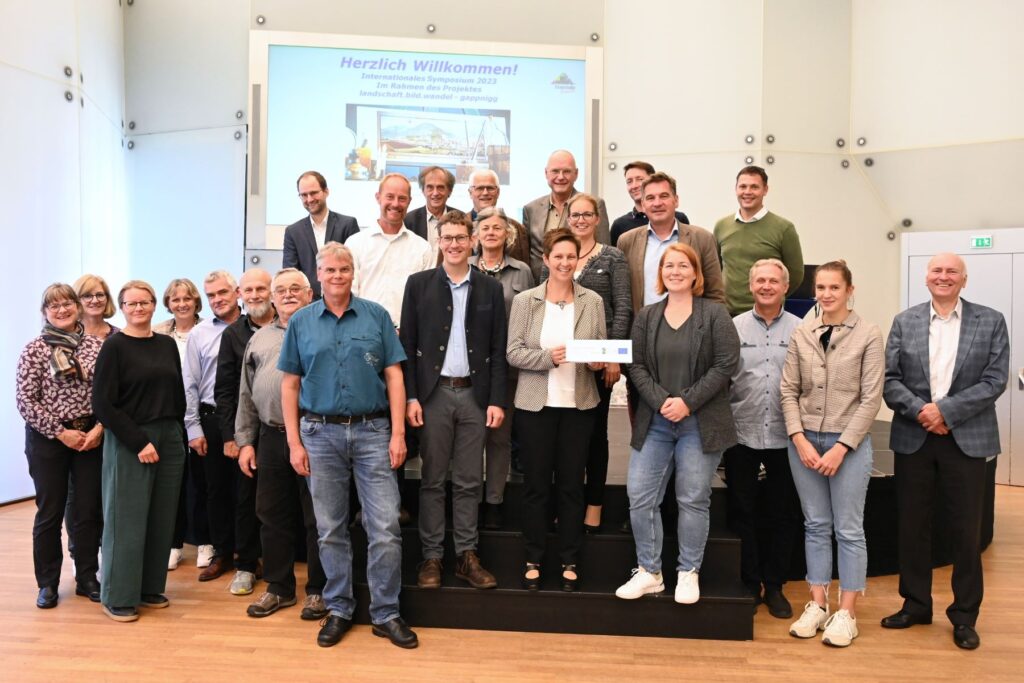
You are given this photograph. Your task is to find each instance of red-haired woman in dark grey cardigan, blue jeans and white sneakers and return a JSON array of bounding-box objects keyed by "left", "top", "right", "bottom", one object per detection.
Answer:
[{"left": 615, "top": 243, "right": 739, "bottom": 604}]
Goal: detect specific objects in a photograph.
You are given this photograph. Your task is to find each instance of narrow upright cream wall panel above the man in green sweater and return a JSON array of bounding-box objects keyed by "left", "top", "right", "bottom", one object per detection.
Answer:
[{"left": 764, "top": 0, "right": 850, "bottom": 154}]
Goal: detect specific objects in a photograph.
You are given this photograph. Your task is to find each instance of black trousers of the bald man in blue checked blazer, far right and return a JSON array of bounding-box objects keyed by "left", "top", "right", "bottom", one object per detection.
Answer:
[{"left": 895, "top": 434, "right": 985, "bottom": 627}]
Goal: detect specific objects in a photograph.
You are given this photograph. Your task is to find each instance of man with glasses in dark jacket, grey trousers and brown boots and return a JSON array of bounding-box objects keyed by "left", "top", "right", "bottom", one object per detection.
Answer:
[{"left": 399, "top": 211, "right": 507, "bottom": 589}]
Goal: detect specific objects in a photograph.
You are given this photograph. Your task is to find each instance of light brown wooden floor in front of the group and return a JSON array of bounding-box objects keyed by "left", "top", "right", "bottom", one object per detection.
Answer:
[{"left": 0, "top": 486, "right": 1024, "bottom": 683}]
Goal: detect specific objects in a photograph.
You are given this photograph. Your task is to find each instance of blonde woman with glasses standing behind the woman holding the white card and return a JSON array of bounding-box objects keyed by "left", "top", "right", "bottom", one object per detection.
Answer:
[{"left": 541, "top": 193, "right": 633, "bottom": 533}]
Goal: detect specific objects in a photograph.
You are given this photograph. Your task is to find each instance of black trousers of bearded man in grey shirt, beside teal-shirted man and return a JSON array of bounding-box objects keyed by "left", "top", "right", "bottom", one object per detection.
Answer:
[{"left": 253, "top": 424, "right": 327, "bottom": 598}]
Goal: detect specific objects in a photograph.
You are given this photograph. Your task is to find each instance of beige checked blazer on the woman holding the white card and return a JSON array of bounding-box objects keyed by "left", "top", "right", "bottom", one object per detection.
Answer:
[{"left": 508, "top": 283, "right": 605, "bottom": 413}]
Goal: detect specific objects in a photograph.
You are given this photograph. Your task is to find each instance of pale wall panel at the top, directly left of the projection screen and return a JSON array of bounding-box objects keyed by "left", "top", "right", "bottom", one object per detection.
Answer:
[{"left": 125, "top": 0, "right": 249, "bottom": 135}]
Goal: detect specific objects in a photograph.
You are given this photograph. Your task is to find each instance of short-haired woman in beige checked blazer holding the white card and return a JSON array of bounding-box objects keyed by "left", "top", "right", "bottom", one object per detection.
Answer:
[{"left": 508, "top": 227, "right": 602, "bottom": 591}]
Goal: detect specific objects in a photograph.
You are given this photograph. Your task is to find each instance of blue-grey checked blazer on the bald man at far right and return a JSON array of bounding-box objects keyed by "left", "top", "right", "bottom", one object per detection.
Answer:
[{"left": 884, "top": 299, "right": 1010, "bottom": 458}]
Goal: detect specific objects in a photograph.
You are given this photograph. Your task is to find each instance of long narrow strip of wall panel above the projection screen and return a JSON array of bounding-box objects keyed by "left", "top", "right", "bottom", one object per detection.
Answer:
[{"left": 249, "top": 0, "right": 598, "bottom": 45}]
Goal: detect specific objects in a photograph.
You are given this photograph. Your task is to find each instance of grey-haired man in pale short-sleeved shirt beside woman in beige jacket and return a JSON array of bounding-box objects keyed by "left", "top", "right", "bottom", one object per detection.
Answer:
[{"left": 725, "top": 258, "right": 801, "bottom": 618}]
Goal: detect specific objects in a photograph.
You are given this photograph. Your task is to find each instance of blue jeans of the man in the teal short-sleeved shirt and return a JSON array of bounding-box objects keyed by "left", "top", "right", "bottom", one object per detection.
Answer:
[{"left": 300, "top": 418, "right": 401, "bottom": 624}]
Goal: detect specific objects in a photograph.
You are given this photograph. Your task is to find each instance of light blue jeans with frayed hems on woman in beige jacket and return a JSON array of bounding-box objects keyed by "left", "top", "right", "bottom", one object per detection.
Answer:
[{"left": 790, "top": 431, "right": 872, "bottom": 592}]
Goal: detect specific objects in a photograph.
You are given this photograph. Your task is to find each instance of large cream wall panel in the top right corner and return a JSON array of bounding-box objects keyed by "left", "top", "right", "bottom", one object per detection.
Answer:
[{"left": 852, "top": 0, "right": 1024, "bottom": 150}]
